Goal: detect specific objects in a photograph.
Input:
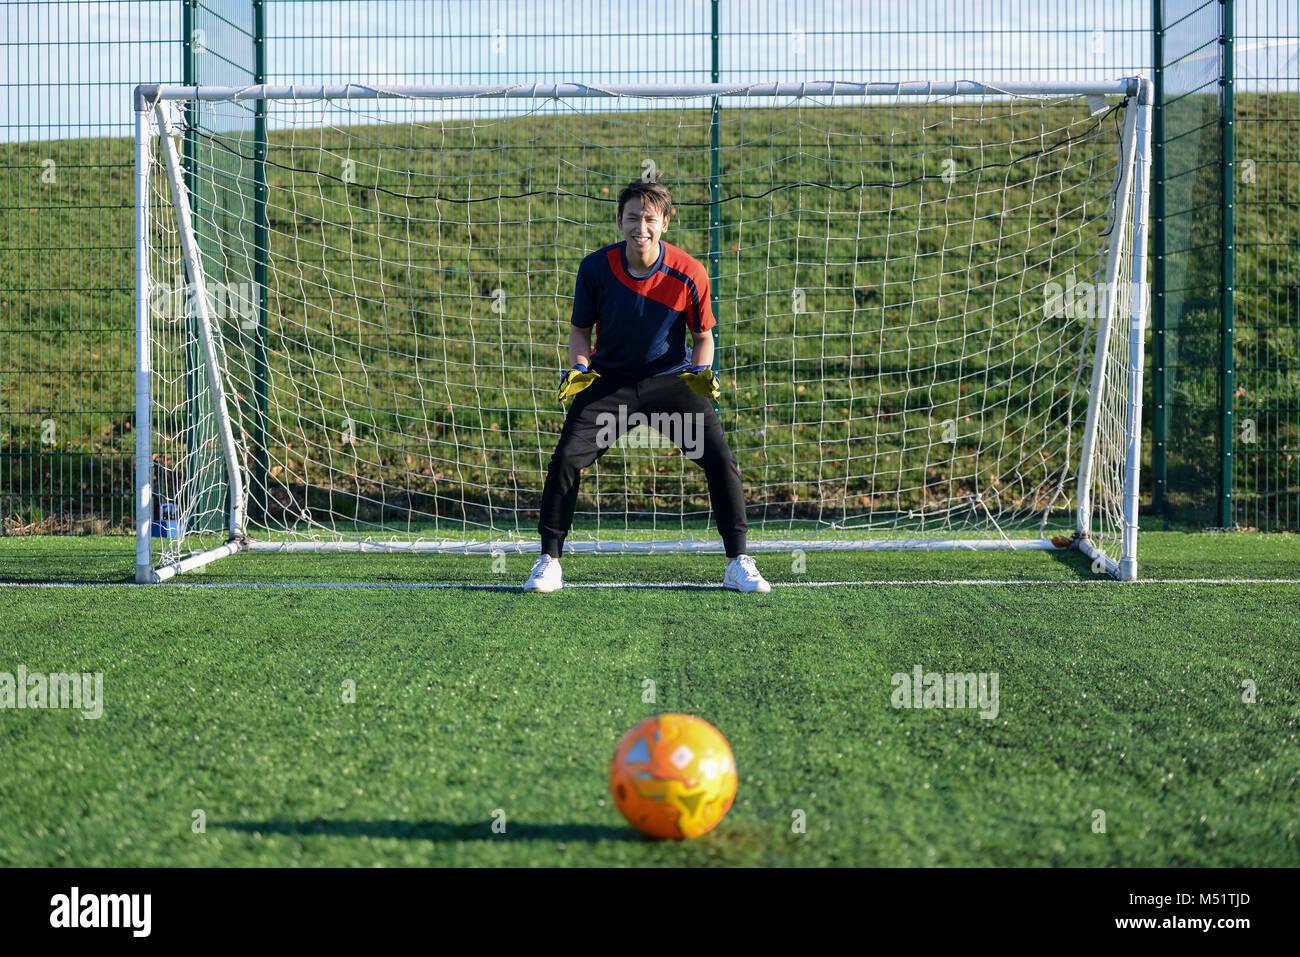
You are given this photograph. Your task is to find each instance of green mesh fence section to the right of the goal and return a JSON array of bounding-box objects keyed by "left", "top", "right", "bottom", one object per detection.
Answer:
[{"left": 1148, "top": 0, "right": 1300, "bottom": 531}]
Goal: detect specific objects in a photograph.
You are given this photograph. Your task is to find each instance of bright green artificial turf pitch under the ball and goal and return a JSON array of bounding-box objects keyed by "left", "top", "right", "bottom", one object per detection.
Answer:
[{"left": 0, "top": 532, "right": 1300, "bottom": 866}]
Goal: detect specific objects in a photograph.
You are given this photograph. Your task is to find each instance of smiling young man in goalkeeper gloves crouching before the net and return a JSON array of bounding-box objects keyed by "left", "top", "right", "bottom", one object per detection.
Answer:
[{"left": 524, "top": 182, "right": 771, "bottom": 592}]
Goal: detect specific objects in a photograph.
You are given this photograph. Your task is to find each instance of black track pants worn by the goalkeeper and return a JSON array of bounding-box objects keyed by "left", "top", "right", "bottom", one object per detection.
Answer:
[{"left": 537, "top": 374, "right": 749, "bottom": 558}]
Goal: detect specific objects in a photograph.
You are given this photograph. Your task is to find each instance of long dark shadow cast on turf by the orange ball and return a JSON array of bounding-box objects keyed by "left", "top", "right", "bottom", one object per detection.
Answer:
[{"left": 213, "top": 818, "right": 650, "bottom": 844}]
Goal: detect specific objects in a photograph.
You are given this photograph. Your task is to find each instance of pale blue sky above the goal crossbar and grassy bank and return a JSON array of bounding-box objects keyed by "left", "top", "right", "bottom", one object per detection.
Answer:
[{"left": 0, "top": 0, "right": 1300, "bottom": 140}]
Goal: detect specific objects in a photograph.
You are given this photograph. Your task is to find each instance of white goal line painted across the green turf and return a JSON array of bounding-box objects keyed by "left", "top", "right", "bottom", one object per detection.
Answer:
[{"left": 0, "top": 579, "right": 1300, "bottom": 592}]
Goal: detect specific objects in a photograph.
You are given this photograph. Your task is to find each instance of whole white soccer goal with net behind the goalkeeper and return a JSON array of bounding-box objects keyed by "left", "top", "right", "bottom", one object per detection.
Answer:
[{"left": 134, "top": 78, "right": 1152, "bottom": 583}]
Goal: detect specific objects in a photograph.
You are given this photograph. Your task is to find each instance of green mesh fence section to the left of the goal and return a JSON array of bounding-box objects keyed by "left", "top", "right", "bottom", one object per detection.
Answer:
[{"left": 0, "top": 0, "right": 181, "bottom": 533}]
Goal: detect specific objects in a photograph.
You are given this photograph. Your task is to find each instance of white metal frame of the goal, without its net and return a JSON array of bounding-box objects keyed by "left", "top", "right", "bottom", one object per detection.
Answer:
[{"left": 134, "top": 77, "right": 1153, "bottom": 584}]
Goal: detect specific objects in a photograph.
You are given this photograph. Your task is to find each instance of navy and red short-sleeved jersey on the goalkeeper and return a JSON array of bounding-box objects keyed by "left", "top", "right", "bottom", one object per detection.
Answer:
[{"left": 572, "top": 239, "right": 714, "bottom": 378}]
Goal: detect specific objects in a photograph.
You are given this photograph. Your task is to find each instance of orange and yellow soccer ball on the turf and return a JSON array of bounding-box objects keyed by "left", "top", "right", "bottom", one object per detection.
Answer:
[{"left": 610, "top": 714, "right": 737, "bottom": 839}]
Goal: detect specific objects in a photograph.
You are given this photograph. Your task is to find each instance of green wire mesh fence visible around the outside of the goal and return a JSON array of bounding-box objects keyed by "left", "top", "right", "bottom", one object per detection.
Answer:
[{"left": 0, "top": 0, "right": 1300, "bottom": 534}]
